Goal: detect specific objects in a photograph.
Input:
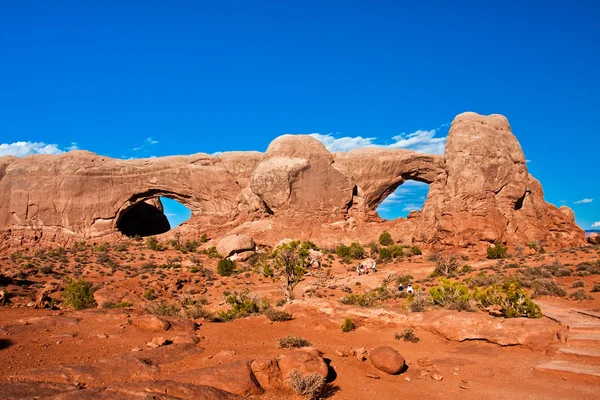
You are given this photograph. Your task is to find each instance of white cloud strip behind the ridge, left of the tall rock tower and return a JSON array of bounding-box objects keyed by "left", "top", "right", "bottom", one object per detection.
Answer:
[{"left": 310, "top": 124, "right": 448, "bottom": 154}]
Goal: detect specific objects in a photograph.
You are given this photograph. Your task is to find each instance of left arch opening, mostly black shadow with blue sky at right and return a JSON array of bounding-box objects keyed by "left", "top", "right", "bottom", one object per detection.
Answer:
[{"left": 116, "top": 196, "right": 191, "bottom": 237}]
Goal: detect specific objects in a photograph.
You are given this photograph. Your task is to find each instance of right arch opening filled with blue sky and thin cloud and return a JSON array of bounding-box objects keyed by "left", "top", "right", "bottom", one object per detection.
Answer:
[{"left": 376, "top": 180, "right": 429, "bottom": 220}]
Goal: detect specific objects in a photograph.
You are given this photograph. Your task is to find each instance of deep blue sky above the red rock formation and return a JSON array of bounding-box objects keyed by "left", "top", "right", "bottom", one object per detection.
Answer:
[{"left": 0, "top": 0, "right": 600, "bottom": 228}]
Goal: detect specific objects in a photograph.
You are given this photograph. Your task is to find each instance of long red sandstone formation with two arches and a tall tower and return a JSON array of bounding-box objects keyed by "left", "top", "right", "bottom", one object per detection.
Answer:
[{"left": 0, "top": 112, "right": 585, "bottom": 248}]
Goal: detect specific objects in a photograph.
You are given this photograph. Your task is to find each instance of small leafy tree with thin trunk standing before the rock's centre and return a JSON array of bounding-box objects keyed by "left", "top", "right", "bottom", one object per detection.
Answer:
[{"left": 271, "top": 240, "right": 316, "bottom": 301}]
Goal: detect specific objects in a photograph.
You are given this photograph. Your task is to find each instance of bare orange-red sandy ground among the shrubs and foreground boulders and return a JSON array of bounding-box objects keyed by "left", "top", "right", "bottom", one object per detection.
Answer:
[{"left": 0, "top": 244, "right": 600, "bottom": 400}]
